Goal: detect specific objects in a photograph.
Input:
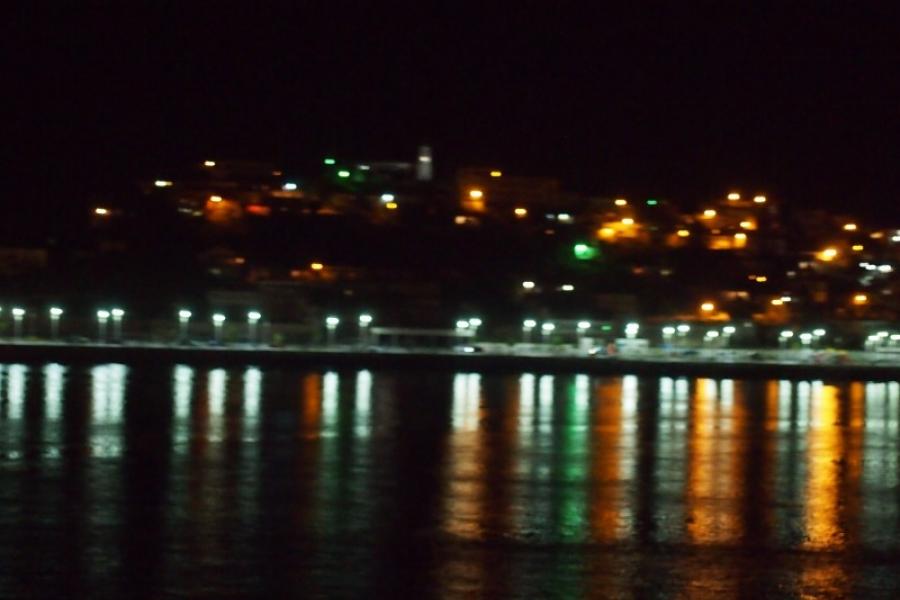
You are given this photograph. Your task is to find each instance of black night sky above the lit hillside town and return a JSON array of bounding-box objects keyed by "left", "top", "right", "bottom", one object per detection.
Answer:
[{"left": 3, "top": 2, "right": 900, "bottom": 216}]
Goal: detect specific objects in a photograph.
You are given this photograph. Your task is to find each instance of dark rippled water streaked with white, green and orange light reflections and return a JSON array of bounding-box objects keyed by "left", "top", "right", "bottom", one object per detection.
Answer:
[{"left": 0, "top": 364, "right": 900, "bottom": 599}]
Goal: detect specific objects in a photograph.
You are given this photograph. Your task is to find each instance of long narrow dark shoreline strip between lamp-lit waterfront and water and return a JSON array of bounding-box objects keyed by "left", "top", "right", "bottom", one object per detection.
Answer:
[{"left": 0, "top": 342, "right": 900, "bottom": 381}]
